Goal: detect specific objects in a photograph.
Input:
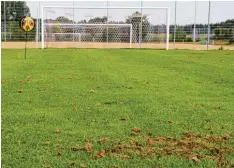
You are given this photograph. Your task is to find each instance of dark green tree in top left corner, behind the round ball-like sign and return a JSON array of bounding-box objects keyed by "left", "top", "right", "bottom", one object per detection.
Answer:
[{"left": 1, "top": 1, "right": 30, "bottom": 21}]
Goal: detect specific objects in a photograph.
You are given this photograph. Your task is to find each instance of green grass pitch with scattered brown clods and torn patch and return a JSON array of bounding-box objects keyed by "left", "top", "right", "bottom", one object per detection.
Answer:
[{"left": 1, "top": 49, "right": 234, "bottom": 168}]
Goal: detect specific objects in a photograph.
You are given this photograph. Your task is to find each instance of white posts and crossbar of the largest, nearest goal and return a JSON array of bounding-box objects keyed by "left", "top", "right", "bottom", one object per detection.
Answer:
[{"left": 41, "top": 6, "right": 170, "bottom": 50}]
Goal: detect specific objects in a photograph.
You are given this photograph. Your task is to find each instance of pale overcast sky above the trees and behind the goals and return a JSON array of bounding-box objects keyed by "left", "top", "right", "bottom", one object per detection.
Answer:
[{"left": 27, "top": 1, "right": 234, "bottom": 24}]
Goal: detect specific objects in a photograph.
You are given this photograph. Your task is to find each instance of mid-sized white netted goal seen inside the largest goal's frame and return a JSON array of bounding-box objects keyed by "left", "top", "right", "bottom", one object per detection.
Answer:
[{"left": 44, "top": 23, "right": 132, "bottom": 48}]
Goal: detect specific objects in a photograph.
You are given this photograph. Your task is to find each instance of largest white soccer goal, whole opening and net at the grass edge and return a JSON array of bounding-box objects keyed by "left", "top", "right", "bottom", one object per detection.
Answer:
[{"left": 41, "top": 6, "right": 170, "bottom": 50}]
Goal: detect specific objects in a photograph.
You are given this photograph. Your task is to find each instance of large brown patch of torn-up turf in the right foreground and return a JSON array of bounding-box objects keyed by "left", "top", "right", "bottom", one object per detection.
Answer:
[{"left": 71, "top": 131, "right": 234, "bottom": 167}]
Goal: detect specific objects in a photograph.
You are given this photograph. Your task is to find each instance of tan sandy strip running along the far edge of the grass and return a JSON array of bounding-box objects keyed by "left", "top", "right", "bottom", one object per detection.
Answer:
[{"left": 1, "top": 41, "right": 234, "bottom": 50}]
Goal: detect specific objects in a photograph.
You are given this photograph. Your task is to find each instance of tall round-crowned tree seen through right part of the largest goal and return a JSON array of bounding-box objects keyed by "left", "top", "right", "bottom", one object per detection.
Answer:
[{"left": 126, "top": 12, "right": 150, "bottom": 42}]
